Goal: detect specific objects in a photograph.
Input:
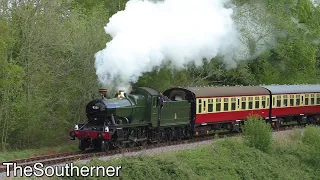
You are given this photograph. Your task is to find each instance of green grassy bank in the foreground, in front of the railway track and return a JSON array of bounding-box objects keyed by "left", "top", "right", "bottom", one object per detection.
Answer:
[{"left": 60, "top": 125, "right": 320, "bottom": 179}]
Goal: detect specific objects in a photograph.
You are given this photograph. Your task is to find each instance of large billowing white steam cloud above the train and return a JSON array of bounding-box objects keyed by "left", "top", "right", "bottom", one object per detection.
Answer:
[{"left": 95, "top": 0, "right": 266, "bottom": 89}]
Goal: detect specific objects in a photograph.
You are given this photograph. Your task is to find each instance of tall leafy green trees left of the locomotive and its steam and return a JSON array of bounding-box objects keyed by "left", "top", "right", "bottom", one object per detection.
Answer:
[{"left": 0, "top": 0, "right": 109, "bottom": 150}]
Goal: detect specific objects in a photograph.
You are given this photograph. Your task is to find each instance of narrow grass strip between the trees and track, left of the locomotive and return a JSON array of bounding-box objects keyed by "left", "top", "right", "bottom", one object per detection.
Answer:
[{"left": 0, "top": 143, "right": 78, "bottom": 162}]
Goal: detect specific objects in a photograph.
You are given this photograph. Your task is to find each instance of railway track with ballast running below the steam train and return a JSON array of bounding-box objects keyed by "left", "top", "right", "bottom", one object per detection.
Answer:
[{"left": 0, "top": 126, "right": 302, "bottom": 173}]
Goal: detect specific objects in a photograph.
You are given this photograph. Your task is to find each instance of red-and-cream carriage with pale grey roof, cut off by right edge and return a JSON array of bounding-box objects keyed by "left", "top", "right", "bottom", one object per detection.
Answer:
[{"left": 262, "top": 85, "right": 320, "bottom": 127}]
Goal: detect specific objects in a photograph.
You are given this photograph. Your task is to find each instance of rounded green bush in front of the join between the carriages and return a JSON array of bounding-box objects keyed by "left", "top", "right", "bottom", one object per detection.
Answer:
[{"left": 243, "top": 115, "right": 272, "bottom": 152}]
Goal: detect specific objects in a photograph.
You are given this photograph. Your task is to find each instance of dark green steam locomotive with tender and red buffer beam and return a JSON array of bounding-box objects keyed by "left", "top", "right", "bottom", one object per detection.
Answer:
[{"left": 70, "top": 87, "right": 192, "bottom": 151}]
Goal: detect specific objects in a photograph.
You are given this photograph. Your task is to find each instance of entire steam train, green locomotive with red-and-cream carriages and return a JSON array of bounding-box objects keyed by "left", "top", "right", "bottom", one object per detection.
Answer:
[{"left": 70, "top": 84, "right": 320, "bottom": 151}]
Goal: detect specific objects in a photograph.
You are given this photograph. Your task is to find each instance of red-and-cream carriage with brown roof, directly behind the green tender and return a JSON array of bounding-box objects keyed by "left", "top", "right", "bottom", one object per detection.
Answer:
[{"left": 164, "top": 86, "right": 270, "bottom": 135}]
